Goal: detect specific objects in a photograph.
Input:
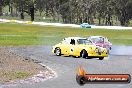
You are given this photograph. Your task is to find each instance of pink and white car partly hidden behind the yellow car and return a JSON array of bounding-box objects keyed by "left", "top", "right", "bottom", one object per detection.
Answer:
[{"left": 87, "top": 36, "right": 112, "bottom": 51}]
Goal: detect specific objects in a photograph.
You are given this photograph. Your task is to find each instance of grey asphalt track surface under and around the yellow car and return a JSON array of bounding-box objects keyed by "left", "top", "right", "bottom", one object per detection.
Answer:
[{"left": 1, "top": 46, "right": 132, "bottom": 88}]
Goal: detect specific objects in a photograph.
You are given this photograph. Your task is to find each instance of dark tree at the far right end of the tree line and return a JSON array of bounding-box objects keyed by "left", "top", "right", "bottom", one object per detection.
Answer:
[{"left": 113, "top": 0, "right": 132, "bottom": 26}]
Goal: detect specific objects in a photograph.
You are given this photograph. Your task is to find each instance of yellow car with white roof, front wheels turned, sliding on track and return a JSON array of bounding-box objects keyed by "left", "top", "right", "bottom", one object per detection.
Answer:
[{"left": 52, "top": 37, "right": 108, "bottom": 60}]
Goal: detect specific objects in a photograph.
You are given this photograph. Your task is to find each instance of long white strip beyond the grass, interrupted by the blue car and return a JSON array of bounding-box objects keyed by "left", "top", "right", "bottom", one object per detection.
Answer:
[{"left": 0, "top": 19, "right": 132, "bottom": 30}]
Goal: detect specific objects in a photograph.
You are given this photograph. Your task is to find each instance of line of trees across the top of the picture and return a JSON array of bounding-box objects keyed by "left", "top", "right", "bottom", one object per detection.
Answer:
[{"left": 0, "top": 0, "right": 132, "bottom": 26}]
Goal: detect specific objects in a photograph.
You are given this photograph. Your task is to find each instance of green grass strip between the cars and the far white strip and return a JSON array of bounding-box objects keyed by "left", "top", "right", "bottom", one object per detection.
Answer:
[{"left": 0, "top": 23, "right": 132, "bottom": 46}]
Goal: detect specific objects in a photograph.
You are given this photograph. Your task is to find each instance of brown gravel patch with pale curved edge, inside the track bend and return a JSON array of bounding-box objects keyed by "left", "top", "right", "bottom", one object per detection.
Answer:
[{"left": 0, "top": 47, "right": 57, "bottom": 86}]
